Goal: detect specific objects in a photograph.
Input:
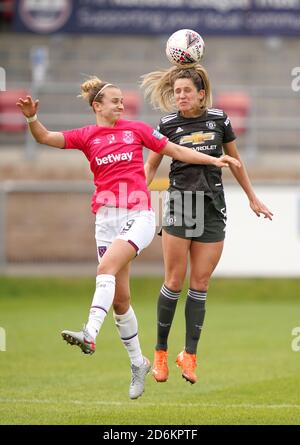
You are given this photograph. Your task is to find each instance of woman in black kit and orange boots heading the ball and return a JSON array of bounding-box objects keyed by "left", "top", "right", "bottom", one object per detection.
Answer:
[{"left": 142, "top": 64, "right": 273, "bottom": 383}]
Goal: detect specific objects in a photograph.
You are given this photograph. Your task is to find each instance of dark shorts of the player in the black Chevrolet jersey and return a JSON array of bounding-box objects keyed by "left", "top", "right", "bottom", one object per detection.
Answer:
[{"left": 162, "top": 191, "right": 226, "bottom": 243}]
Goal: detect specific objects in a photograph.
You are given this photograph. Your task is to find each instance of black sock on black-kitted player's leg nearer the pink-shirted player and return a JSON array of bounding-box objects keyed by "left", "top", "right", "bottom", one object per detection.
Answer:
[{"left": 155, "top": 284, "right": 180, "bottom": 351}]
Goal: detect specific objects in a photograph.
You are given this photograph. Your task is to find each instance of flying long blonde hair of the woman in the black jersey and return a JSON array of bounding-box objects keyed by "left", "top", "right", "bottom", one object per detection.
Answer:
[{"left": 141, "top": 64, "right": 212, "bottom": 111}]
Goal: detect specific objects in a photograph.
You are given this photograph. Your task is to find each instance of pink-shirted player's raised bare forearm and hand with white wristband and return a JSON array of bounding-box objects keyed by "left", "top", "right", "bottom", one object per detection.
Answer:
[{"left": 16, "top": 96, "right": 65, "bottom": 148}]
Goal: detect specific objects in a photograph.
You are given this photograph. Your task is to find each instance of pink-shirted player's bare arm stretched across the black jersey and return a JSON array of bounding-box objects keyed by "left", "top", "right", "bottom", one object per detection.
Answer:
[{"left": 160, "top": 141, "right": 241, "bottom": 167}]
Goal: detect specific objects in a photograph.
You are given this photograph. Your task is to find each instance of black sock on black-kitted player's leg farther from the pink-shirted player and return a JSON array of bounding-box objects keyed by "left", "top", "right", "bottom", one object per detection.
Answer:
[{"left": 185, "top": 289, "right": 206, "bottom": 354}]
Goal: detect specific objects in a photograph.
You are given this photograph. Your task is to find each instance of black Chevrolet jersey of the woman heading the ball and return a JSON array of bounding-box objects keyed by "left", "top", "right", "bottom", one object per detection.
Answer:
[{"left": 158, "top": 108, "right": 236, "bottom": 198}]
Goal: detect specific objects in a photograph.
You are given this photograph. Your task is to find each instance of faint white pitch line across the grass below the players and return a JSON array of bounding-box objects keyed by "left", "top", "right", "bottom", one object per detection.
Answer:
[{"left": 0, "top": 399, "right": 300, "bottom": 409}]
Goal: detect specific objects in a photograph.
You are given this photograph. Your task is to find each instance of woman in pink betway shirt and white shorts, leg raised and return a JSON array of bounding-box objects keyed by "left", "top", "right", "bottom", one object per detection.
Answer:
[{"left": 17, "top": 77, "right": 239, "bottom": 399}]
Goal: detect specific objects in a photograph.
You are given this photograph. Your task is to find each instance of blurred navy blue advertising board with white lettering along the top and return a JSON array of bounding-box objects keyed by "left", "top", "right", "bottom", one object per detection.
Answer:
[{"left": 14, "top": 0, "right": 300, "bottom": 36}]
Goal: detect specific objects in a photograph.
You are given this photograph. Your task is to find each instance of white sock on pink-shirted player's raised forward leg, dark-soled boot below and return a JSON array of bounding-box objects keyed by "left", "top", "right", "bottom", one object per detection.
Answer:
[{"left": 86, "top": 274, "right": 116, "bottom": 338}]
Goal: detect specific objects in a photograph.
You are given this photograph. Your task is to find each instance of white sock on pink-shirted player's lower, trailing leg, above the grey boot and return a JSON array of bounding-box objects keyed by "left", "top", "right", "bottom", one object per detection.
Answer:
[{"left": 114, "top": 306, "right": 144, "bottom": 366}]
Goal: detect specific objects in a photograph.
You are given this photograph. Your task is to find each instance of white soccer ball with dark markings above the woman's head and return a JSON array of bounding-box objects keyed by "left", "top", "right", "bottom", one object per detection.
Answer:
[{"left": 166, "top": 29, "right": 205, "bottom": 66}]
